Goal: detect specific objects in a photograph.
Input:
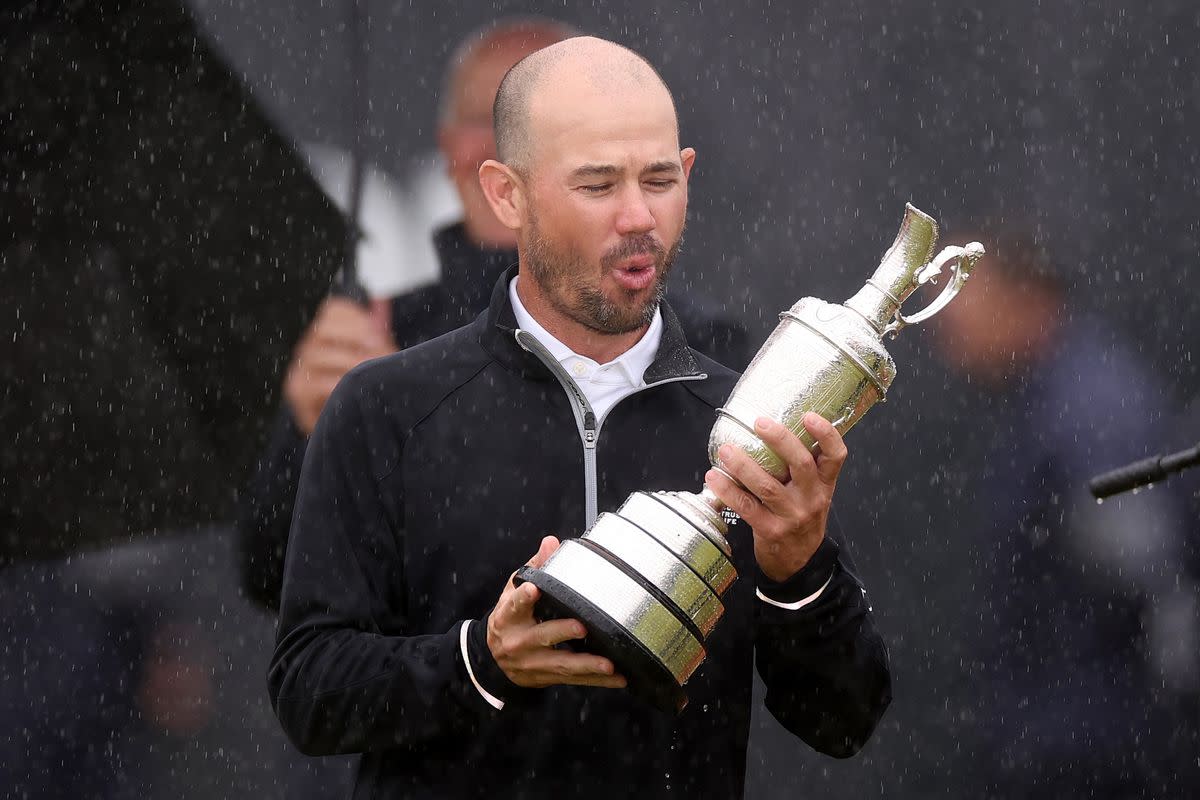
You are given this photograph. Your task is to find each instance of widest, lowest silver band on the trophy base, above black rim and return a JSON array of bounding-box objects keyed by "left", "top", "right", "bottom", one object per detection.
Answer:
[{"left": 542, "top": 540, "right": 704, "bottom": 686}]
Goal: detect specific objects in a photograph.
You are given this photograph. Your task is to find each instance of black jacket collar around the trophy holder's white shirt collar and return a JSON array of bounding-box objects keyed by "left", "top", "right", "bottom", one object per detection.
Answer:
[{"left": 480, "top": 265, "right": 704, "bottom": 384}]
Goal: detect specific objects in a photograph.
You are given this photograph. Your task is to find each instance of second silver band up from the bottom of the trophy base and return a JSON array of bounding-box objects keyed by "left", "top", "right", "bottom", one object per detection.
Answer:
[{"left": 583, "top": 513, "right": 725, "bottom": 636}]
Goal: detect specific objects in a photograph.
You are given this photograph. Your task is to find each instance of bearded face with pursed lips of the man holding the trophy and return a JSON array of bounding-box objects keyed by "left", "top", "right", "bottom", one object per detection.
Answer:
[{"left": 520, "top": 85, "right": 695, "bottom": 333}]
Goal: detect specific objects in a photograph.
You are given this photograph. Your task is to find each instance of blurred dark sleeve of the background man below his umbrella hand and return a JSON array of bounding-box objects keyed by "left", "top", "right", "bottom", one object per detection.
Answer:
[{"left": 238, "top": 407, "right": 308, "bottom": 610}]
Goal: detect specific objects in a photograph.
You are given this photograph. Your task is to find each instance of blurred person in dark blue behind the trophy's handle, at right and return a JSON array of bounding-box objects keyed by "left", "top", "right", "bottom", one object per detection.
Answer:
[{"left": 935, "top": 221, "right": 1195, "bottom": 798}]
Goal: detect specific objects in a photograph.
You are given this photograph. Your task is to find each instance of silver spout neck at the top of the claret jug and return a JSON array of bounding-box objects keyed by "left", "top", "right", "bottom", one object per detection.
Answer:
[{"left": 842, "top": 204, "right": 937, "bottom": 335}]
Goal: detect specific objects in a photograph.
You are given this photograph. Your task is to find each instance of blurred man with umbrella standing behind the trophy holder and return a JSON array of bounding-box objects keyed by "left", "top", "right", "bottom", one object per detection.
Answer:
[{"left": 240, "top": 18, "right": 746, "bottom": 609}]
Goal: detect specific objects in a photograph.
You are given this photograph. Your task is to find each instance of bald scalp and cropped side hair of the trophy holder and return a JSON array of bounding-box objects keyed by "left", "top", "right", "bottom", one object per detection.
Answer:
[{"left": 493, "top": 36, "right": 678, "bottom": 172}]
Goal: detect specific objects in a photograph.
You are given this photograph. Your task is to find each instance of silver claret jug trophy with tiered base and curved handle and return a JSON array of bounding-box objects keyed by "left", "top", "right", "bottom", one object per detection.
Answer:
[{"left": 517, "top": 205, "right": 984, "bottom": 711}]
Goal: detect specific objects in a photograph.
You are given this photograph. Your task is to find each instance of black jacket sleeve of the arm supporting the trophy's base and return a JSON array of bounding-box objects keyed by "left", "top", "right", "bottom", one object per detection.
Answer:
[{"left": 268, "top": 372, "right": 497, "bottom": 756}]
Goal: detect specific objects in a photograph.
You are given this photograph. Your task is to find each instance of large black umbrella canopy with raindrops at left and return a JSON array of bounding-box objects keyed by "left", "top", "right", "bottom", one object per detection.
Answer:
[{"left": 0, "top": 0, "right": 347, "bottom": 561}]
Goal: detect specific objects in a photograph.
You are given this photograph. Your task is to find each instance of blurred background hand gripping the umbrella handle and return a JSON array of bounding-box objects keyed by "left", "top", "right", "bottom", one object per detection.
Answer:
[{"left": 283, "top": 297, "right": 396, "bottom": 435}]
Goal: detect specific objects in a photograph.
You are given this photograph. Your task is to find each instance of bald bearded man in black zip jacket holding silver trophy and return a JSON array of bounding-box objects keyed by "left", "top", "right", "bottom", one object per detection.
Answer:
[{"left": 270, "top": 37, "right": 890, "bottom": 798}]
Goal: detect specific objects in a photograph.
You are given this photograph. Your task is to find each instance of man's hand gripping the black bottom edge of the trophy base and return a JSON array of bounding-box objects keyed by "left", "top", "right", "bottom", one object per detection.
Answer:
[{"left": 487, "top": 536, "right": 625, "bottom": 688}]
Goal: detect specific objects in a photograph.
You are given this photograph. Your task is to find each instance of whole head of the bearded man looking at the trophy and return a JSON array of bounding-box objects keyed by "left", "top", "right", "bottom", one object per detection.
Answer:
[{"left": 479, "top": 37, "right": 696, "bottom": 363}]
